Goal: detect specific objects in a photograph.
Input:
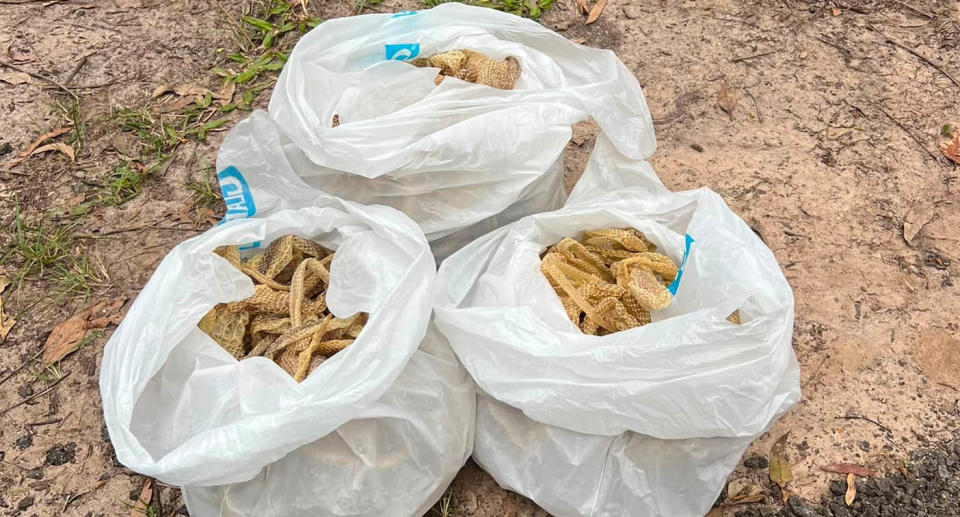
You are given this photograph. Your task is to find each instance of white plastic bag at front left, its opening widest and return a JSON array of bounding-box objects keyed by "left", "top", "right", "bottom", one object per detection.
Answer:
[{"left": 100, "top": 137, "right": 475, "bottom": 517}]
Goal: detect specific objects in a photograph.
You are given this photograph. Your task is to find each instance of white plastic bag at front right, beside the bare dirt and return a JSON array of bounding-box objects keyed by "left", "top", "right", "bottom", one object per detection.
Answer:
[{"left": 434, "top": 137, "right": 800, "bottom": 517}]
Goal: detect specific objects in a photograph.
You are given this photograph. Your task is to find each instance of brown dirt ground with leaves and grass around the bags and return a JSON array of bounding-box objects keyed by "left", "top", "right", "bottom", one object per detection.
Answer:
[{"left": 0, "top": 0, "right": 960, "bottom": 517}]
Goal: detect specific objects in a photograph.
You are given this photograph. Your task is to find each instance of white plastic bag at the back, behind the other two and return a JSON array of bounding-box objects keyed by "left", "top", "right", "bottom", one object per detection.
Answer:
[{"left": 253, "top": 3, "right": 655, "bottom": 260}]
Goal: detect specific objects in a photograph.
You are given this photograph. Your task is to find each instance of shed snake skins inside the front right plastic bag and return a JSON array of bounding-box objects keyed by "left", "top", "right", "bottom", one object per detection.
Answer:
[{"left": 540, "top": 228, "right": 677, "bottom": 336}]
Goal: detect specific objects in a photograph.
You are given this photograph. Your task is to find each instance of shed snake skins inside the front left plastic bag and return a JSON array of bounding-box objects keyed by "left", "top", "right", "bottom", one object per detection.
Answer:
[{"left": 197, "top": 235, "right": 367, "bottom": 382}]
